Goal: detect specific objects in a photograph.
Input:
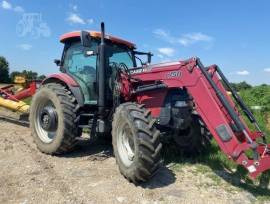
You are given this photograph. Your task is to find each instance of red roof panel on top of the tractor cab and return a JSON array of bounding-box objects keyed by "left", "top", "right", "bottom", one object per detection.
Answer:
[{"left": 60, "top": 31, "right": 136, "bottom": 49}]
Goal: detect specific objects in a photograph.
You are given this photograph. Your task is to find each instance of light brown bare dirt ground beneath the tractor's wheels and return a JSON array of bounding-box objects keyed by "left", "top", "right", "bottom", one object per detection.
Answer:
[{"left": 0, "top": 120, "right": 270, "bottom": 204}]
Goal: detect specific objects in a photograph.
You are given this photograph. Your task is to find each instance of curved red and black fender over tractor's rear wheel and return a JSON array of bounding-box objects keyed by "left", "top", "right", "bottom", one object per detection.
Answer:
[{"left": 41, "top": 73, "right": 84, "bottom": 106}]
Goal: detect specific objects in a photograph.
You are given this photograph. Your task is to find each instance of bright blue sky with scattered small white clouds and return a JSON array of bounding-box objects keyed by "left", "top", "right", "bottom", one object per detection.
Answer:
[{"left": 0, "top": 0, "right": 270, "bottom": 85}]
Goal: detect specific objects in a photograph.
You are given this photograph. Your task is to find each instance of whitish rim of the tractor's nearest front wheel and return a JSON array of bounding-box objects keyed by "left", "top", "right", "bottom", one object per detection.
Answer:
[{"left": 117, "top": 123, "right": 135, "bottom": 167}]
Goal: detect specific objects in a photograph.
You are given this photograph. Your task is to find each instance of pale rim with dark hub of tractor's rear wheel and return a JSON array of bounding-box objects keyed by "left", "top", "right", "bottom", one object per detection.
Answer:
[{"left": 35, "top": 99, "right": 58, "bottom": 144}]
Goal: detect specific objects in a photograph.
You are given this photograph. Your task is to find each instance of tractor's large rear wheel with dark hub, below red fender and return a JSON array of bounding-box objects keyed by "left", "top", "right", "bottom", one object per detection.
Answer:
[{"left": 30, "top": 83, "right": 81, "bottom": 154}]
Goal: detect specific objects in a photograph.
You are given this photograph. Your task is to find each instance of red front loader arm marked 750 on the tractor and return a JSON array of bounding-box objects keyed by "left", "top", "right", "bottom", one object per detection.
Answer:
[{"left": 133, "top": 58, "right": 270, "bottom": 178}]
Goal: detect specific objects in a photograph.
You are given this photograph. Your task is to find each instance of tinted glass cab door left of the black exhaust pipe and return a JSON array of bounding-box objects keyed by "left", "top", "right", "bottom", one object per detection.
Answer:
[{"left": 63, "top": 41, "right": 98, "bottom": 105}]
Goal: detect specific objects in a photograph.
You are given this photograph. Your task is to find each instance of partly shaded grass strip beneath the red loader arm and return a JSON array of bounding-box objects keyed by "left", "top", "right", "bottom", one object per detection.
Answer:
[{"left": 163, "top": 140, "right": 270, "bottom": 201}]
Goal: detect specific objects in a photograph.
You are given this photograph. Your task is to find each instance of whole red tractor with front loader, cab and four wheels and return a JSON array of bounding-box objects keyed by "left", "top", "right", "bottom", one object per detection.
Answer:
[{"left": 30, "top": 23, "right": 270, "bottom": 183}]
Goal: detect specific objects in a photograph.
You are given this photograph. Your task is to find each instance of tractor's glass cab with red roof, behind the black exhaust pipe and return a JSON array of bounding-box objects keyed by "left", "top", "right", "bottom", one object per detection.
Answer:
[{"left": 57, "top": 31, "right": 148, "bottom": 105}]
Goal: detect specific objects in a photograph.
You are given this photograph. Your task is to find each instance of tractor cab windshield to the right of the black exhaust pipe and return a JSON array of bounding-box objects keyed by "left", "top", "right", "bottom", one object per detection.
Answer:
[{"left": 106, "top": 44, "right": 135, "bottom": 68}]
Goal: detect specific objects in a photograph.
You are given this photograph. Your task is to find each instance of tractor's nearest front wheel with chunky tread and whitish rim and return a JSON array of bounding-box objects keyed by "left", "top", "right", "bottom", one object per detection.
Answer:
[{"left": 112, "top": 102, "right": 162, "bottom": 184}]
